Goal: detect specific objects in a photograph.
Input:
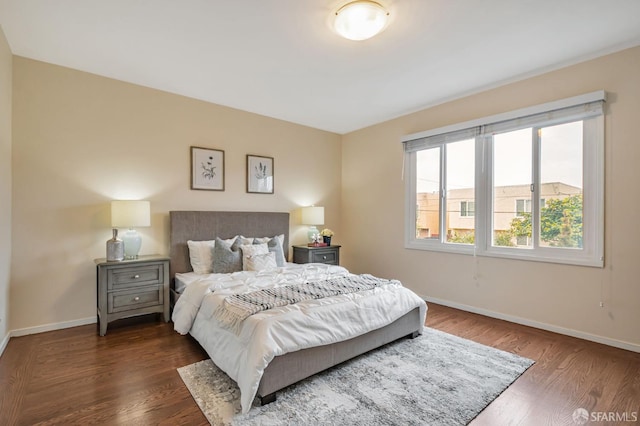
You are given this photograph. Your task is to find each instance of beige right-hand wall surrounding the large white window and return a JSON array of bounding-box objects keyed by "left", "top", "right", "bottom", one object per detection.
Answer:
[{"left": 341, "top": 48, "right": 640, "bottom": 350}]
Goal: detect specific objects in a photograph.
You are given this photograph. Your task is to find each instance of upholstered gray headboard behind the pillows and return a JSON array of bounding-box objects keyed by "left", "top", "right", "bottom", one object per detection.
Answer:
[{"left": 169, "top": 211, "right": 289, "bottom": 281}]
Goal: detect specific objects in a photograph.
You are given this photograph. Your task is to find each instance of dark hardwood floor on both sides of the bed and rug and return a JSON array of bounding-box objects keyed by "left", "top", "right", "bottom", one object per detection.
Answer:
[{"left": 0, "top": 304, "right": 640, "bottom": 426}]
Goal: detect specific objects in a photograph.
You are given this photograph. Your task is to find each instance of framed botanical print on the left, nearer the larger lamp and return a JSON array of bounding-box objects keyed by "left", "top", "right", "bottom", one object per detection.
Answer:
[{"left": 191, "top": 146, "right": 224, "bottom": 191}]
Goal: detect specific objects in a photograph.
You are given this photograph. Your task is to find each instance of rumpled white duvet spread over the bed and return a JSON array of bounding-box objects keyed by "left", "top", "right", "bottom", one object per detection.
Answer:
[{"left": 172, "top": 263, "right": 426, "bottom": 413}]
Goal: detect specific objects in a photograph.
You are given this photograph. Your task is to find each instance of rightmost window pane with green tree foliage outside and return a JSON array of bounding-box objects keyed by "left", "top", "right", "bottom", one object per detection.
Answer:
[{"left": 540, "top": 121, "right": 583, "bottom": 249}]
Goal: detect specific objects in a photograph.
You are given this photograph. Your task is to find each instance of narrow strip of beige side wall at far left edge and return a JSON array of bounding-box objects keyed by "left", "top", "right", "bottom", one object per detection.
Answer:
[{"left": 0, "top": 29, "right": 12, "bottom": 346}]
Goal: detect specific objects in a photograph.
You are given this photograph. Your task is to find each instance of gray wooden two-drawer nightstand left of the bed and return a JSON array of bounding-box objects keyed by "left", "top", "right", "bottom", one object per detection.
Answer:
[{"left": 95, "top": 255, "right": 169, "bottom": 336}]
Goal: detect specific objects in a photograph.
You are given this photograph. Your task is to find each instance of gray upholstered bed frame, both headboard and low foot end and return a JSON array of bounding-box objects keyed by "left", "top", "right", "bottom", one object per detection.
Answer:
[{"left": 169, "top": 211, "right": 422, "bottom": 405}]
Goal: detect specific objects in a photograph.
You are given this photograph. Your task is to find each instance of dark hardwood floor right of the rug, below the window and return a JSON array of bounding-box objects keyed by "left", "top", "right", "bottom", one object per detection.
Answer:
[{"left": 427, "top": 304, "right": 640, "bottom": 426}]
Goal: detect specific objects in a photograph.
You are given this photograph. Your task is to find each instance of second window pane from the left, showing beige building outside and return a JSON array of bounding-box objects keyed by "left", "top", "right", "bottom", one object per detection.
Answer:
[{"left": 445, "top": 139, "right": 475, "bottom": 244}]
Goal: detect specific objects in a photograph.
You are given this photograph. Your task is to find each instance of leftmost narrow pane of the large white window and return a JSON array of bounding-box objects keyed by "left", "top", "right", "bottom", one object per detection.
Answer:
[{"left": 416, "top": 148, "right": 441, "bottom": 239}]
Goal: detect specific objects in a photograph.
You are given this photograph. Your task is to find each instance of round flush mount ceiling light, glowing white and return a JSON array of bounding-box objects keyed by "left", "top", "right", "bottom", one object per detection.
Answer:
[{"left": 333, "top": 0, "right": 389, "bottom": 40}]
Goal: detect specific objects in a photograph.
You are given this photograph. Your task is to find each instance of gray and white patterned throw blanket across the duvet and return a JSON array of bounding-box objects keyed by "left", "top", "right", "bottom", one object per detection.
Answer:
[{"left": 213, "top": 274, "right": 394, "bottom": 332}]
